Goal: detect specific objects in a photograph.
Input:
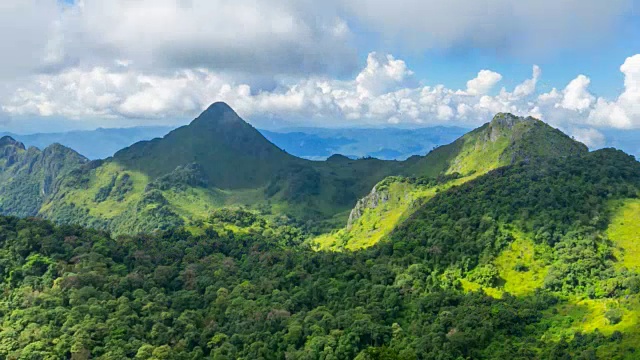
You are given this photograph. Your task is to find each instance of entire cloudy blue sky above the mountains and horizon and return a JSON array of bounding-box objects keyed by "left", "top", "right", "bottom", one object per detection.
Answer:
[{"left": 0, "top": 0, "right": 640, "bottom": 147}]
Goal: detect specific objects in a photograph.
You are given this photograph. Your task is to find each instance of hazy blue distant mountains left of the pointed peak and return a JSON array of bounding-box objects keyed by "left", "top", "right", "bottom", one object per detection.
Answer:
[{"left": 0, "top": 126, "right": 173, "bottom": 160}]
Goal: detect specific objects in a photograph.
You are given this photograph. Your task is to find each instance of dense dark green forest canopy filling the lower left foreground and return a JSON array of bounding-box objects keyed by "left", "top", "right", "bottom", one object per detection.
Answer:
[{"left": 0, "top": 218, "right": 555, "bottom": 359}]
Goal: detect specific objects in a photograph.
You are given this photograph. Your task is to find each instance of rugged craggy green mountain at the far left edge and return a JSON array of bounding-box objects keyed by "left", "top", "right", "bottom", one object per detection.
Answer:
[{"left": 0, "top": 136, "right": 87, "bottom": 217}]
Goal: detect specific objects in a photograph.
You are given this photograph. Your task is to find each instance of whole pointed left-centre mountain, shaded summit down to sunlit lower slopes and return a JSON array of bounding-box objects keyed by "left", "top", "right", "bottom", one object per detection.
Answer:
[{"left": 33, "top": 103, "right": 402, "bottom": 233}]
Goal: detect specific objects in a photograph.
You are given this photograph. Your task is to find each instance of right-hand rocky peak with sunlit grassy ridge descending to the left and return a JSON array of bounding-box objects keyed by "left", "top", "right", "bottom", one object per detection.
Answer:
[{"left": 313, "top": 114, "right": 588, "bottom": 250}]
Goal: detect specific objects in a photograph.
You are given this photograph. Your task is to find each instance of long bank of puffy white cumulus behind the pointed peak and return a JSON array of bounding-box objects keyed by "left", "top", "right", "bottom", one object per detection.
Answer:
[{"left": 4, "top": 53, "right": 535, "bottom": 125}]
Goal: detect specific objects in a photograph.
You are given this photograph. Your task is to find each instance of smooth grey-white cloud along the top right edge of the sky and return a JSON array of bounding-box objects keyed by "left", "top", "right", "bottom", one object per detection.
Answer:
[{"left": 340, "top": 0, "right": 633, "bottom": 54}]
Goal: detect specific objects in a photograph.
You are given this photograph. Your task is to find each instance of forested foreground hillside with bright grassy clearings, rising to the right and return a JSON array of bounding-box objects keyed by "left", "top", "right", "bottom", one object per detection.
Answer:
[{"left": 0, "top": 149, "right": 640, "bottom": 360}]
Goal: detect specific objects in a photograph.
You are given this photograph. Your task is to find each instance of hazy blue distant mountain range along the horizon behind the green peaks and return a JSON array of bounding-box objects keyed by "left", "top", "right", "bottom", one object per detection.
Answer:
[{"left": 0, "top": 121, "right": 640, "bottom": 160}]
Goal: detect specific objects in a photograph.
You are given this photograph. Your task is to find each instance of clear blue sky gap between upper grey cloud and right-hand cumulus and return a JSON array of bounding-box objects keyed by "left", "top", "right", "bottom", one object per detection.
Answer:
[{"left": 352, "top": 5, "right": 640, "bottom": 98}]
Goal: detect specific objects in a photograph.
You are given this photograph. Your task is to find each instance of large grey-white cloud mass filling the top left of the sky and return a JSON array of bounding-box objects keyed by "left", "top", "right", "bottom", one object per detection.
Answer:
[{"left": 0, "top": 0, "right": 357, "bottom": 77}]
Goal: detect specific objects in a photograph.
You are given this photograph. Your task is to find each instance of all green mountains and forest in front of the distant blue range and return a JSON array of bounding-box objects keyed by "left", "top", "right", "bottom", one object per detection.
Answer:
[{"left": 0, "top": 103, "right": 640, "bottom": 360}]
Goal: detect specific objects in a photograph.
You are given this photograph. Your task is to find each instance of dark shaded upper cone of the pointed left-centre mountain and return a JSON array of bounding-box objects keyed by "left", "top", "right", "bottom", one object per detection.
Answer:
[{"left": 113, "top": 102, "right": 299, "bottom": 189}]
